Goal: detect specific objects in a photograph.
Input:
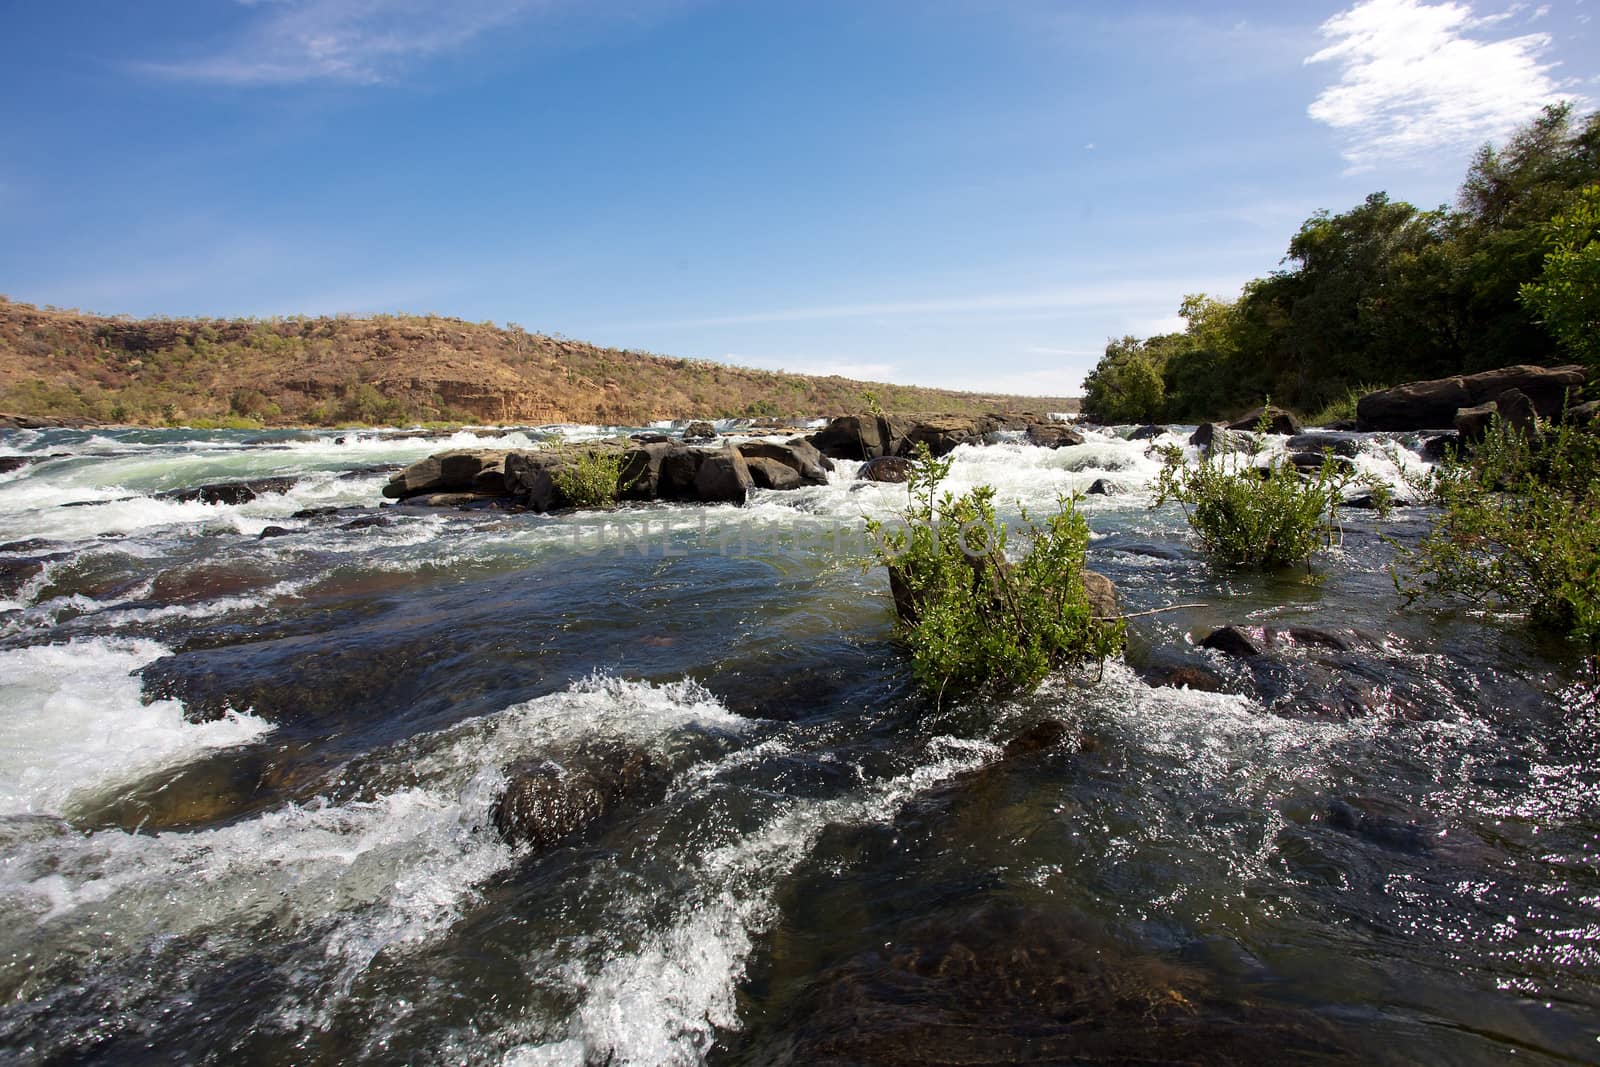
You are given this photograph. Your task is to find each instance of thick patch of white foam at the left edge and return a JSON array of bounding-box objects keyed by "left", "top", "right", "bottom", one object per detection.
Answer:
[{"left": 0, "top": 638, "right": 270, "bottom": 814}]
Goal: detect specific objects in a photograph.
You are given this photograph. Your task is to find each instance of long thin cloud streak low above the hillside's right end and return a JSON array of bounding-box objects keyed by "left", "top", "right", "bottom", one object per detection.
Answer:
[{"left": 617, "top": 278, "right": 1216, "bottom": 330}]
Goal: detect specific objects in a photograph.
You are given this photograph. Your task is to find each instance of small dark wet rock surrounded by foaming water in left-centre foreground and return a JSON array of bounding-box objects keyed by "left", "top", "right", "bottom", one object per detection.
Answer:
[{"left": 490, "top": 747, "right": 651, "bottom": 851}]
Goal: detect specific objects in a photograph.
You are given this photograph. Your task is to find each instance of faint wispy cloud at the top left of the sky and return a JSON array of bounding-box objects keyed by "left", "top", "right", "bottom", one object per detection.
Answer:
[{"left": 141, "top": 0, "right": 557, "bottom": 85}]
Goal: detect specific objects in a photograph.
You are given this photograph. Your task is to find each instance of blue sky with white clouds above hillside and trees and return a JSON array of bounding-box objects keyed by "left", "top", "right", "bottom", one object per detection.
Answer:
[{"left": 0, "top": 0, "right": 1600, "bottom": 394}]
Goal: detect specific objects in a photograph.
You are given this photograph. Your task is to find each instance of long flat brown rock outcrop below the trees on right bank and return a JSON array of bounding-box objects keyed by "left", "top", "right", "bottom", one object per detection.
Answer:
[{"left": 1355, "top": 365, "right": 1587, "bottom": 430}]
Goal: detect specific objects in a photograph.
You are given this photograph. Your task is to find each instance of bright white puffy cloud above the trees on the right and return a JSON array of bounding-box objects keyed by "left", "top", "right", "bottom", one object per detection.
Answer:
[{"left": 1306, "top": 0, "right": 1571, "bottom": 171}]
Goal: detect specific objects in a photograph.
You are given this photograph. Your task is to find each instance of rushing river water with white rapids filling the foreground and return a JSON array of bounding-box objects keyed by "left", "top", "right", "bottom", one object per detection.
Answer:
[{"left": 0, "top": 427, "right": 1600, "bottom": 1064}]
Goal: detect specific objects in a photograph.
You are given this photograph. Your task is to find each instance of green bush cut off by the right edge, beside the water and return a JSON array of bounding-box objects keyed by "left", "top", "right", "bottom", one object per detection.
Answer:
[{"left": 1392, "top": 418, "right": 1600, "bottom": 661}]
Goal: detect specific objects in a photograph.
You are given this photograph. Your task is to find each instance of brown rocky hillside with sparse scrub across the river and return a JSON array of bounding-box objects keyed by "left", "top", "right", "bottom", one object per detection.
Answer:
[{"left": 0, "top": 298, "right": 1077, "bottom": 426}]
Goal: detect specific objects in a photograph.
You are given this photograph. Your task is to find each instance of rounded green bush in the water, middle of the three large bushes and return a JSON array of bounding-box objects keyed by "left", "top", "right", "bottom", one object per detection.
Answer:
[{"left": 1154, "top": 412, "right": 1387, "bottom": 571}]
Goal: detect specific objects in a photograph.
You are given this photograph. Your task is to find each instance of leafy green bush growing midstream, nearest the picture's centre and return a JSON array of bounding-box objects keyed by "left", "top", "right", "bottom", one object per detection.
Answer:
[{"left": 867, "top": 445, "right": 1123, "bottom": 696}]
